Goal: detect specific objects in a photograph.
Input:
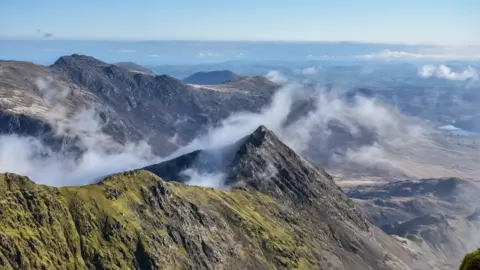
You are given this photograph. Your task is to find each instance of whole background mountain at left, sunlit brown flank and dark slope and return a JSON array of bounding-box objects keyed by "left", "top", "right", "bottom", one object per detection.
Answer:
[{"left": 0, "top": 54, "right": 278, "bottom": 155}]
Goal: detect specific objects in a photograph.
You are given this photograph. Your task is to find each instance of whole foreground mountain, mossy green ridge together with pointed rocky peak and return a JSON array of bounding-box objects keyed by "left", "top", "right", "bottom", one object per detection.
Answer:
[{"left": 0, "top": 127, "right": 415, "bottom": 269}]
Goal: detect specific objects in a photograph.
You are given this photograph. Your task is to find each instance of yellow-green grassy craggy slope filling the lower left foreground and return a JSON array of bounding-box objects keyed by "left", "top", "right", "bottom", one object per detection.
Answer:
[{"left": 0, "top": 171, "right": 326, "bottom": 269}]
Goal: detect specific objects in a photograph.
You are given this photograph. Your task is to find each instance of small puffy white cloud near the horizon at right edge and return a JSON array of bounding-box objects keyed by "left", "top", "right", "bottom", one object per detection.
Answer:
[{"left": 418, "top": 65, "right": 478, "bottom": 81}]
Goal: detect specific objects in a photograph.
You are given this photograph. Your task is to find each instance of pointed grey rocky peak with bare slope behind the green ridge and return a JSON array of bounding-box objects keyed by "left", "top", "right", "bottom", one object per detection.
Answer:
[{"left": 144, "top": 126, "right": 413, "bottom": 269}]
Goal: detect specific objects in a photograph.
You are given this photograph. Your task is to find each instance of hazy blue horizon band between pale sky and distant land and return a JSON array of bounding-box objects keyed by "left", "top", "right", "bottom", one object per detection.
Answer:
[{"left": 0, "top": 38, "right": 480, "bottom": 65}]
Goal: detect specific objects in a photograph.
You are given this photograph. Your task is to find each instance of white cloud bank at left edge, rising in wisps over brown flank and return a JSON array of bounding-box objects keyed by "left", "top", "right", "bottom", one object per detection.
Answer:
[{"left": 0, "top": 78, "right": 154, "bottom": 186}]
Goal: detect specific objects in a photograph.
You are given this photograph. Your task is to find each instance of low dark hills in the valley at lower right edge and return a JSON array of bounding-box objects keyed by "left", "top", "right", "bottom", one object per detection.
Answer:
[{"left": 347, "top": 178, "right": 480, "bottom": 269}]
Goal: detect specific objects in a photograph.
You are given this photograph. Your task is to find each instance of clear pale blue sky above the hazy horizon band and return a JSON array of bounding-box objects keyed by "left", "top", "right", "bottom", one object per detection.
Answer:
[{"left": 0, "top": 0, "right": 480, "bottom": 44}]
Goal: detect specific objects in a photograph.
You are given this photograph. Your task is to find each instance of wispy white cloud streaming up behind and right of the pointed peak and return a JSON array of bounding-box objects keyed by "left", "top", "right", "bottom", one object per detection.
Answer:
[{"left": 167, "top": 75, "right": 424, "bottom": 188}]
